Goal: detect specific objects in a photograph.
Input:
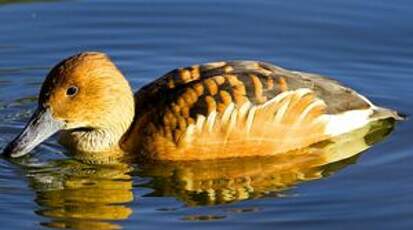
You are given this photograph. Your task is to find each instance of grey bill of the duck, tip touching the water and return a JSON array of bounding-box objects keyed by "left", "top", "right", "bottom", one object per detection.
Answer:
[{"left": 3, "top": 108, "right": 64, "bottom": 158}]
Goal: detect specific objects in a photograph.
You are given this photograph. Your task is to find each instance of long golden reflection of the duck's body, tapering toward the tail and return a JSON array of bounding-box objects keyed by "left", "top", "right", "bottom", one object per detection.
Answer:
[{"left": 141, "top": 120, "right": 394, "bottom": 206}]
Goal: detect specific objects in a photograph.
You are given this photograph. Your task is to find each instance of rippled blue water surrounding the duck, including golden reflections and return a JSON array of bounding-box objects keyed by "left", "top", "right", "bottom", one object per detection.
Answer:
[{"left": 0, "top": 0, "right": 413, "bottom": 229}]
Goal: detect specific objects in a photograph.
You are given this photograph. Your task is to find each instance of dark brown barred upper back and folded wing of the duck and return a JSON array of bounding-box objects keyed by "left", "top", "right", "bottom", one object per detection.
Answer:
[{"left": 135, "top": 61, "right": 370, "bottom": 115}]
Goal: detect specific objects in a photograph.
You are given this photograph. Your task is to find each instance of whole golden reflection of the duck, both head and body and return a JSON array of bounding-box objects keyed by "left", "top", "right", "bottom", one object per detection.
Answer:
[{"left": 18, "top": 120, "right": 394, "bottom": 229}]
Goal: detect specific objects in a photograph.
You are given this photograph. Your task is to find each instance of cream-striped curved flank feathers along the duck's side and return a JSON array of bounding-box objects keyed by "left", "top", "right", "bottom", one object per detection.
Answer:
[{"left": 179, "top": 88, "right": 326, "bottom": 144}]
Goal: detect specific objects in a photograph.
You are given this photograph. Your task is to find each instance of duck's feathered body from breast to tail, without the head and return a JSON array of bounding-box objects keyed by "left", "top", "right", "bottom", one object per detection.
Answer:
[{"left": 126, "top": 61, "right": 397, "bottom": 160}]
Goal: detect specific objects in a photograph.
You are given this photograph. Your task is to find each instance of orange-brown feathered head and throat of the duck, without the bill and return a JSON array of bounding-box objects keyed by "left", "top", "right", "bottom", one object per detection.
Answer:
[{"left": 39, "top": 53, "right": 134, "bottom": 155}]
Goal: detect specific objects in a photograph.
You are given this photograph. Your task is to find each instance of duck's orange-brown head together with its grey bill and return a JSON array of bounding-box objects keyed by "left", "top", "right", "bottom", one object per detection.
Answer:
[{"left": 4, "top": 52, "right": 134, "bottom": 157}]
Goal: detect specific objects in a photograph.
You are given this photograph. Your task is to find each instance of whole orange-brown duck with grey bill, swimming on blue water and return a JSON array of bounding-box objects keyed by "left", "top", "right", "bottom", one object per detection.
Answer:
[{"left": 3, "top": 52, "right": 403, "bottom": 161}]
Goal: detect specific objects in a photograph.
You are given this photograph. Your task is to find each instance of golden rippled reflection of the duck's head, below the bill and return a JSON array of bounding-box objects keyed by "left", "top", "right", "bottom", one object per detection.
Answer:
[{"left": 28, "top": 161, "right": 134, "bottom": 229}]
